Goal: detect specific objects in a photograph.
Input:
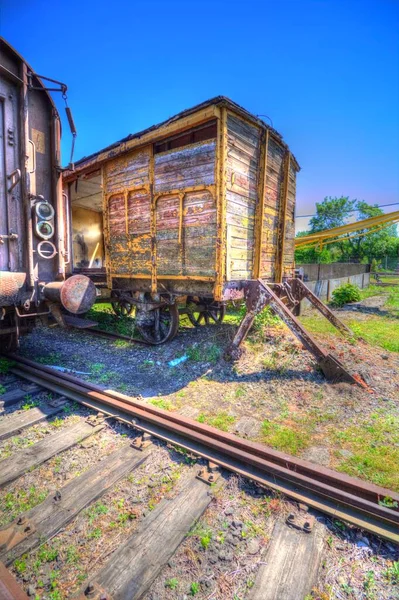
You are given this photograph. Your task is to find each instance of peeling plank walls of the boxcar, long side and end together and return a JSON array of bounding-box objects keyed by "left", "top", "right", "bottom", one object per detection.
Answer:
[{"left": 103, "top": 104, "right": 297, "bottom": 298}]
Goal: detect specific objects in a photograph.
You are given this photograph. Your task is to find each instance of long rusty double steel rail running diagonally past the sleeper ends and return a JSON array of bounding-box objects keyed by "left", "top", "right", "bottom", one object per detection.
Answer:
[{"left": 5, "top": 355, "right": 399, "bottom": 542}]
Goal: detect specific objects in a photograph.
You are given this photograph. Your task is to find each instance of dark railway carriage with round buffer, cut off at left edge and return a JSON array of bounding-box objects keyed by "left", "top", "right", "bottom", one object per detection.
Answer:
[{"left": 0, "top": 38, "right": 95, "bottom": 350}]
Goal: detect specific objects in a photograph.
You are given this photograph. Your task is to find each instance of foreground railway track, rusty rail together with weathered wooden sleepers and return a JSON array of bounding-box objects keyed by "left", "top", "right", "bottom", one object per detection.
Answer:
[{"left": 0, "top": 355, "right": 399, "bottom": 600}]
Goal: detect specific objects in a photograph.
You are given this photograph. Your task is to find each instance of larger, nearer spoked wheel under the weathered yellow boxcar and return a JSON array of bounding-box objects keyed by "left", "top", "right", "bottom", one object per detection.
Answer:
[{"left": 136, "top": 304, "right": 179, "bottom": 345}]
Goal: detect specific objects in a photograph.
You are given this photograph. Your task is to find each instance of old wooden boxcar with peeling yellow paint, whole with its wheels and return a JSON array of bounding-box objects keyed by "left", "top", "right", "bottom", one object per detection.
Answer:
[{"left": 64, "top": 96, "right": 299, "bottom": 343}]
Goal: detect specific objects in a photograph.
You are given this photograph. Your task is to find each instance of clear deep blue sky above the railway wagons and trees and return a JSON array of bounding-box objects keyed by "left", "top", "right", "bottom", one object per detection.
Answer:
[{"left": 0, "top": 0, "right": 399, "bottom": 229}]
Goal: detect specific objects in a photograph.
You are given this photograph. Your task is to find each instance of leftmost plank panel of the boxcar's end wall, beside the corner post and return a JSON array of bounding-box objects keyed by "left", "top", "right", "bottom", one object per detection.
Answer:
[{"left": 226, "top": 113, "right": 261, "bottom": 280}]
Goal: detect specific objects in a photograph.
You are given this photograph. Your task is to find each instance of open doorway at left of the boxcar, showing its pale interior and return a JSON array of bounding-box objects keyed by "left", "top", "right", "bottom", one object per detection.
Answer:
[{"left": 68, "top": 170, "right": 105, "bottom": 278}]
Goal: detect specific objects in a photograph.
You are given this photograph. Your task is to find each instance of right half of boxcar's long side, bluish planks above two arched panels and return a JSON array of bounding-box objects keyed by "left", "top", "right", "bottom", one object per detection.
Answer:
[{"left": 154, "top": 140, "right": 216, "bottom": 277}]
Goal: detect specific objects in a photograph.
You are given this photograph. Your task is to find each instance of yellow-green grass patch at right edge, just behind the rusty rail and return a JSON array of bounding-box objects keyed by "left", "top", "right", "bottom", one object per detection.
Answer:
[{"left": 331, "top": 409, "right": 399, "bottom": 491}]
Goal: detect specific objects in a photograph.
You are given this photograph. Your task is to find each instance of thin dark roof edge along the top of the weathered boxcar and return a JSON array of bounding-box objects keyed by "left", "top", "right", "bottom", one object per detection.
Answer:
[{"left": 64, "top": 96, "right": 300, "bottom": 179}]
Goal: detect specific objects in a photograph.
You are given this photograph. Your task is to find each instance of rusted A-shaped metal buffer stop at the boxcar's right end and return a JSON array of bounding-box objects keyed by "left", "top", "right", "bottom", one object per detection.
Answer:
[{"left": 226, "top": 279, "right": 364, "bottom": 386}]
